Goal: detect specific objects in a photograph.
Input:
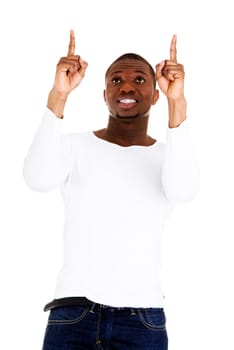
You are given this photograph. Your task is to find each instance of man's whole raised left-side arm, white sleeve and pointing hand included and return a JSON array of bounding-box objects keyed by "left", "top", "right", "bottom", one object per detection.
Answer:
[{"left": 23, "top": 31, "right": 87, "bottom": 191}]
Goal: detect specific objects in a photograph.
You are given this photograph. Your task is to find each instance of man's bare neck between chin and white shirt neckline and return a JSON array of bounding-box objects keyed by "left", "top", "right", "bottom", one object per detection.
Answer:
[{"left": 95, "top": 116, "right": 155, "bottom": 146}]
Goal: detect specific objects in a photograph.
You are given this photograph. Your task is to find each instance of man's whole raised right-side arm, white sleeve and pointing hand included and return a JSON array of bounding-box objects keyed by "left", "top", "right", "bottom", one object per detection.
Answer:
[{"left": 160, "top": 35, "right": 200, "bottom": 202}]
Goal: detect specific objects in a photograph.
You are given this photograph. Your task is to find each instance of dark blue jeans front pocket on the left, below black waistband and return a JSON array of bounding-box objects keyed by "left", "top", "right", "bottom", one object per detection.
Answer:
[{"left": 48, "top": 306, "right": 90, "bottom": 325}]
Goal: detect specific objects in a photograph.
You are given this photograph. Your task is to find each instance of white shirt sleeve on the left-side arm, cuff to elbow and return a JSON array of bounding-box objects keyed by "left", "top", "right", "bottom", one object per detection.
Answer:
[{"left": 23, "top": 108, "right": 72, "bottom": 192}]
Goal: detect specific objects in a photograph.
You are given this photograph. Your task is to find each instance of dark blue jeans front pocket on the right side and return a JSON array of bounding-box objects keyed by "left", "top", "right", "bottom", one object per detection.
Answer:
[{"left": 138, "top": 308, "right": 166, "bottom": 331}]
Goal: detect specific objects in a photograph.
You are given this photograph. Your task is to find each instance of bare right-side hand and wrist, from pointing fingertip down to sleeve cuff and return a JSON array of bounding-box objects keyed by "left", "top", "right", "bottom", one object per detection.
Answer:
[{"left": 156, "top": 35, "right": 186, "bottom": 128}]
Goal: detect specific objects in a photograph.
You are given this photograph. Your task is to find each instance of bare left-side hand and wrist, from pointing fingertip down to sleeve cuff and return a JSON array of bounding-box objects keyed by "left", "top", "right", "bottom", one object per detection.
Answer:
[{"left": 47, "top": 30, "right": 88, "bottom": 118}]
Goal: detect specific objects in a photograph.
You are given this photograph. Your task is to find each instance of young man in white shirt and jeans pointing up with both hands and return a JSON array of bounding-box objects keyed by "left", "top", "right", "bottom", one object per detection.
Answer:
[{"left": 24, "top": 31, "right": 199, "bottom": 350}]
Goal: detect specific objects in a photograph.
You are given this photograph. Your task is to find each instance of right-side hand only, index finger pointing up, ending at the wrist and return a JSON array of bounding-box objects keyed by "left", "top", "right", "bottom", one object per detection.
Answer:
[{"left": 156, "top": 35, "right": 184, "bottom": 100}]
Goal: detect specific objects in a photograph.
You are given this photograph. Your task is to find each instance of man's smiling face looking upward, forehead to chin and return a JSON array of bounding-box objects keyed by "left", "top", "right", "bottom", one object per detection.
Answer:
[{"left": 104, "top": 58, "right": 158, "bottom": 118}]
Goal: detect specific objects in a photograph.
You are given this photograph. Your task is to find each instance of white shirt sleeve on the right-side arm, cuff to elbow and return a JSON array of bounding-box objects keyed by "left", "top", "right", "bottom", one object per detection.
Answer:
[{"left": 162, "top": 120, "right": 200, "bottom": 203}]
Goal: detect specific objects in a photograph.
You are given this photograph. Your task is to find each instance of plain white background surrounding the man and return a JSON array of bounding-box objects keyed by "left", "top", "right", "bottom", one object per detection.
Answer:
[{"left": 0, "top": 0, "right": 234, "bottom": 350}]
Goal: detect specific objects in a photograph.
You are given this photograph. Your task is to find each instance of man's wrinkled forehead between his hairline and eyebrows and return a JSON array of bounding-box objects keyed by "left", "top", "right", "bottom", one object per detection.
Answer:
[{"left": 107, "top": 58, "right": 151, "bottom": 76}]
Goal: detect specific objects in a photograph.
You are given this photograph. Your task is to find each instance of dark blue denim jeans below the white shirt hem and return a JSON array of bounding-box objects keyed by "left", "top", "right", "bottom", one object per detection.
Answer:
[{"left": 43, "top": 303, "right": 168, "bottom": 350}]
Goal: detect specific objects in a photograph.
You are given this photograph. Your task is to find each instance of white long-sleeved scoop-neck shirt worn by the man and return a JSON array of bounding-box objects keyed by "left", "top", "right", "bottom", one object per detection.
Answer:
[{"left": 23, "top": 109, "right": 199, "bottom": 307}]
